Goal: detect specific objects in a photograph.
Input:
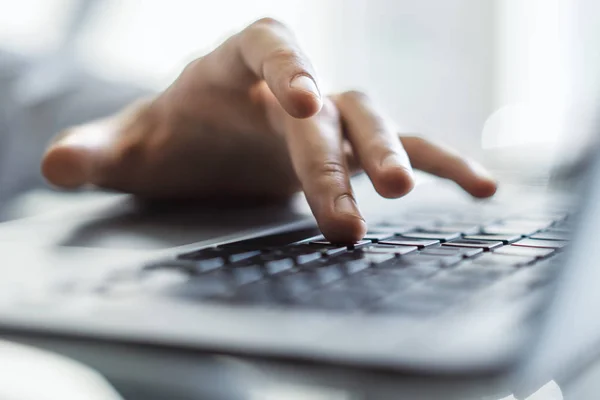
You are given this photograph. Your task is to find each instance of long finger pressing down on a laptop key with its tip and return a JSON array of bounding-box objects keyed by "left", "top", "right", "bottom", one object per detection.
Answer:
[{"left": 286, "top": 101, "right": 366, "bottom": 243}]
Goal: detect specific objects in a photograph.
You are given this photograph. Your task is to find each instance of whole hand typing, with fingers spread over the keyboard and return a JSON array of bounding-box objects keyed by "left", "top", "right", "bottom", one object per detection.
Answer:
[{"left": 42, "top": 19, "right": 496, "bottom": 242}]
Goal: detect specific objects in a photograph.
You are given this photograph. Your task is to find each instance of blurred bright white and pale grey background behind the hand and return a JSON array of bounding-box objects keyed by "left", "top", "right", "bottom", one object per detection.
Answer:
[{"left": 0, "top": 0, "right": 600, "bottom": 212}]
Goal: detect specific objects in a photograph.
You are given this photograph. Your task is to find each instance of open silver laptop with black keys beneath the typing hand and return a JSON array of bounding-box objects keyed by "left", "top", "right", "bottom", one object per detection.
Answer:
[{"left": 0, "top": 4, "right": 600, "bottom": 398}]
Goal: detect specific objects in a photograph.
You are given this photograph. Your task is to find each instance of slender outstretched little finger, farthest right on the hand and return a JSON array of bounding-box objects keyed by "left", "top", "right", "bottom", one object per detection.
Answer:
[{"left": 401, "top": 137, "right": 497, "bottom": 197}]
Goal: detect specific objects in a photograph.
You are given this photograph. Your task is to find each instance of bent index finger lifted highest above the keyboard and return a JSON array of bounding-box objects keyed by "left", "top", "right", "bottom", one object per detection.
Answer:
[{"left": 209, "top": 18, "right": 322, "bottom": 118}]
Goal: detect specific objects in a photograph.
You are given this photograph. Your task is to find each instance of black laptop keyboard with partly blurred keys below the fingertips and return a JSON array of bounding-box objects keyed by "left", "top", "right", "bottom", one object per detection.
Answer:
[{"left": 98, "top": 208, "right": 569, "bottom": 317}]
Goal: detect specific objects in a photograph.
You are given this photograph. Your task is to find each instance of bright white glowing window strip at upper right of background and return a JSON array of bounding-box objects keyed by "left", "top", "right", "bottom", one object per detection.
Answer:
[{"left": 482, "top": 0, "right": 570, "bottom": 148}]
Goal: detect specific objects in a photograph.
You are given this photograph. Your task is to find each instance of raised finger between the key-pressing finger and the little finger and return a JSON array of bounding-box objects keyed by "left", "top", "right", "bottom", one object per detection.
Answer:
[{"left": 336, "top": 92, "right": 414, "bottom": 198}]
